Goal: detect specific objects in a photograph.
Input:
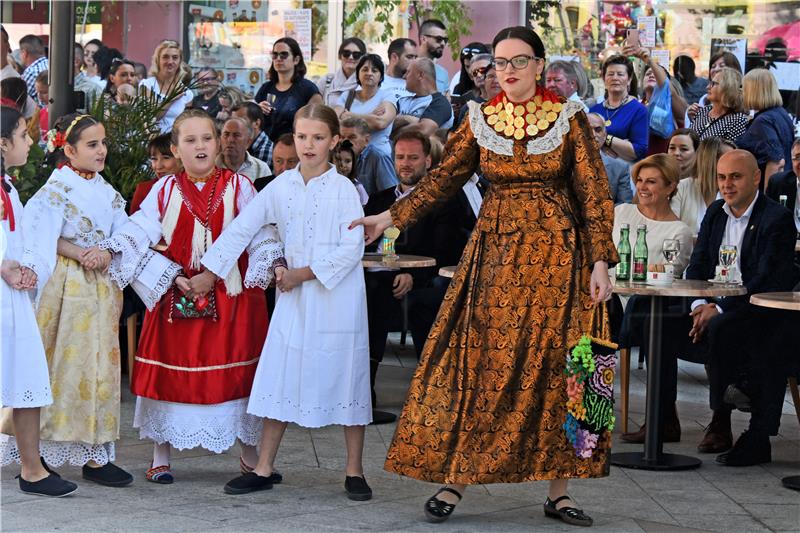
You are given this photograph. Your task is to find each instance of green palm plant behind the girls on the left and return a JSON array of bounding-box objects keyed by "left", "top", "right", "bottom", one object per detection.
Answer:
[{"left": 11, "top": 82, "right": 197, "bottom": 203}]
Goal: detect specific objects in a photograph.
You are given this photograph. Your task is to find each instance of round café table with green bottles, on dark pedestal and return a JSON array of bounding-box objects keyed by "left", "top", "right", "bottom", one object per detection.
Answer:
[{"left": 611, "top": 280, "right": 747, "bottom": 470}]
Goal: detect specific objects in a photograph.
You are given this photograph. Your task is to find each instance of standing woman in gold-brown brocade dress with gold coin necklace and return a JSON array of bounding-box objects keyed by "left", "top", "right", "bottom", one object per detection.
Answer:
[{"left": 354, "top": 27, "right": 617, "bottom": 526}]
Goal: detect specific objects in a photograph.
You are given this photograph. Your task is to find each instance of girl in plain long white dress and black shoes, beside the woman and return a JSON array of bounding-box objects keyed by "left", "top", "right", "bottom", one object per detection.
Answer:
[{"left": 202, "top": 104, "right": 372, "bottom": 500}]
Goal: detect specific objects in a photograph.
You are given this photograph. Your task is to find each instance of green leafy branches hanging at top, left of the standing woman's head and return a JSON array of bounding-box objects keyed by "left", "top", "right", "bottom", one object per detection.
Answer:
[{"left": 344, "top": 0, "right": 472, "bottom": 60}]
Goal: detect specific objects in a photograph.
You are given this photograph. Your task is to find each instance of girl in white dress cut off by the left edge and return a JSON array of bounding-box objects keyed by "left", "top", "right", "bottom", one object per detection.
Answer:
[{"left": 0, "top": 106, "right": 78, "bottom": 497}]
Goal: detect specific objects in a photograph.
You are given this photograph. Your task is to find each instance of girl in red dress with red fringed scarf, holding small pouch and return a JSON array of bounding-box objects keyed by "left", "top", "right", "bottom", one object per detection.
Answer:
[{"left": 100, "top": 109, "right": 274, "bottom": 484}]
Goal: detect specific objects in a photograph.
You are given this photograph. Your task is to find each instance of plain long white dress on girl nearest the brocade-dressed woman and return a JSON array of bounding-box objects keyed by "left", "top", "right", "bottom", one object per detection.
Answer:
[{"left": 203, "top": 165, "right": 372, "bottom": 427}]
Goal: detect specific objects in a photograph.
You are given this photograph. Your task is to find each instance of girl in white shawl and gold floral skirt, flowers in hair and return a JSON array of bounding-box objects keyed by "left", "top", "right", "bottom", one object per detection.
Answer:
[{"left": 3, "top": 115, "right": 133, "bottom": 487}]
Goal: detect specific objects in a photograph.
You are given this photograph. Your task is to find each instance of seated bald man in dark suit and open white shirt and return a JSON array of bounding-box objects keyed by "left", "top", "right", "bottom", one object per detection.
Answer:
[{"left": 646, "top": 150, "right": 797, "bottom": 466}]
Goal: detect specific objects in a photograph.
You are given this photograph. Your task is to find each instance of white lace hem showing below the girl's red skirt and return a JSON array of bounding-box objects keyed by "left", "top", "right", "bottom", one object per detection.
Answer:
[{"left": 133, "top": 397, "right": 263, "bottom": 453}]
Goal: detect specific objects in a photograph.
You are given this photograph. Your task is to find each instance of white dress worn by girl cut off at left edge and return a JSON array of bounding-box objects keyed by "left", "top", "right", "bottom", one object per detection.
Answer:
[{"left": 0, "top": 176, "right": 53, "bottom": 412}]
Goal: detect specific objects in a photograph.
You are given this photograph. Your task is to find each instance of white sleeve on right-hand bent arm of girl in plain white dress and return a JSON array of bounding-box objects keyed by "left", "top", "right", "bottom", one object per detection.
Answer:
[{"left": 311, "top": 184, "right": 364, "bottom": 290}]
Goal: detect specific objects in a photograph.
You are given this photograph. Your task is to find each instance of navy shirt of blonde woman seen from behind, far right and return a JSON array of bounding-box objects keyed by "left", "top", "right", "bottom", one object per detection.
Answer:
[{"left": 736, "top": 106, "right": 794, "bottom": 175}]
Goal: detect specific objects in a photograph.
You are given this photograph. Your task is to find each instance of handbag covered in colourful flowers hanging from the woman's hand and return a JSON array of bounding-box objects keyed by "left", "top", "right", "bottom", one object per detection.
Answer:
[{"left": 564, "top": 303, "right": 617, "bottom": 459}]
